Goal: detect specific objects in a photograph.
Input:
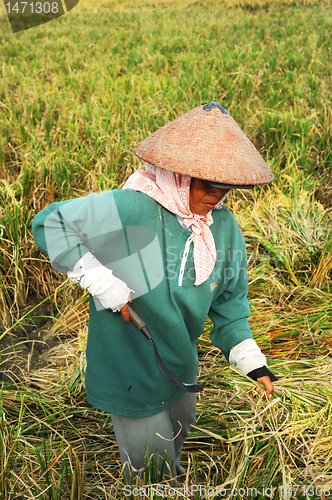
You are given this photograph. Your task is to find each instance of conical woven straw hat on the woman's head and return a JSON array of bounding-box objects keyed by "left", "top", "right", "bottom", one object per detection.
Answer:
[{"left": 134, "top": 102, "right": 274, "bottom": 186}]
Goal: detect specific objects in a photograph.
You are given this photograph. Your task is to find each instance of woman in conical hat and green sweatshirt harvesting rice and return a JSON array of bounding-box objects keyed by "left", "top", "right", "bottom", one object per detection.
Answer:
[{"left": 33, "top": 103, "right": 276, "bottom": 481}]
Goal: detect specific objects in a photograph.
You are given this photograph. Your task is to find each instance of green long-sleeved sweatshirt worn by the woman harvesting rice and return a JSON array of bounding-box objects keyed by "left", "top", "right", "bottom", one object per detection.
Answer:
[{"left": 32, "top": 189, "right": 253, "bottom": 417}]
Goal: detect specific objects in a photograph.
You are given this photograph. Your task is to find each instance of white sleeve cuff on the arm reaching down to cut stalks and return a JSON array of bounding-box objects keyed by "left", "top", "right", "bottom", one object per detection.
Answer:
[{"left": 229, "top": 339, "right": 267, "bottom": 375}]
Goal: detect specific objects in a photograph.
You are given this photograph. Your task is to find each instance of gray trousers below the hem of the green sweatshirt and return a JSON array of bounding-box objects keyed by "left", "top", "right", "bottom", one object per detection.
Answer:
[{"left": 111, "top": 381, "right": 196, "bottom": 483}]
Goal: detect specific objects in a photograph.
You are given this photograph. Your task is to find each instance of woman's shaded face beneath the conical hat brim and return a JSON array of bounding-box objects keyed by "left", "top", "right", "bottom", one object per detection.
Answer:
[{"left": 189, "top": 177, "right": 230, "bottom": 215}]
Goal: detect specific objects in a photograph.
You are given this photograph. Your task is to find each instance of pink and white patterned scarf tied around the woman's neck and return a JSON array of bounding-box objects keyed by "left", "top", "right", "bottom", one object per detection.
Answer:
[{"left": 122, "top": 163, "right": 223, "bottom": 286}]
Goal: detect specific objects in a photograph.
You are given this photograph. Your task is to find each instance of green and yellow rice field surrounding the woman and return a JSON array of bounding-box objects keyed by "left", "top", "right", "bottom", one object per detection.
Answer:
[{"left": 0, "top": 0, "right": 332, "bottom": 500}]
